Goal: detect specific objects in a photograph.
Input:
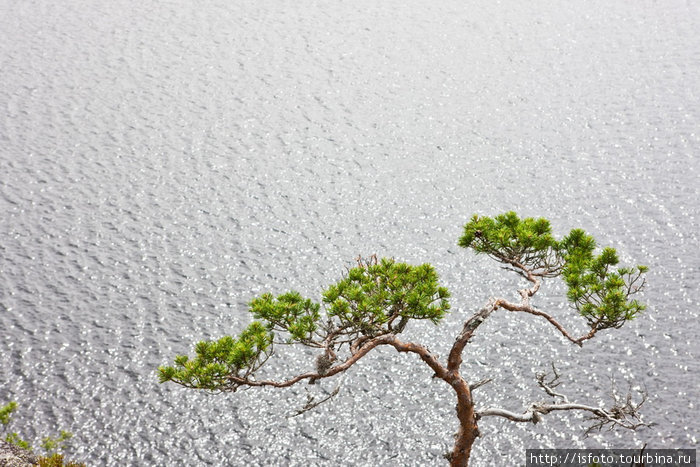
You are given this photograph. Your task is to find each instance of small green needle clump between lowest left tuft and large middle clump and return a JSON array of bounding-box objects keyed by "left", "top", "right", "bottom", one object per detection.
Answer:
[{"left": 250, "top": 292, "right": 321, "bottom": 342}]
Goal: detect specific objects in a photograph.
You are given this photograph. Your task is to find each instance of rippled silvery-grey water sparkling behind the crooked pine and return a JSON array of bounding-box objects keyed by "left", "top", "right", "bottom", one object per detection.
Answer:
[{"left": 0, "top": 0, "right": 700, "bottom": 466}]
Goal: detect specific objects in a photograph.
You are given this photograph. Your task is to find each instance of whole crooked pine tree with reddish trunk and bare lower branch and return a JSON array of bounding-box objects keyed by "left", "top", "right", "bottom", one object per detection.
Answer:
[{"left": 159, "top": 212, "right": 647, "bottom": 466}]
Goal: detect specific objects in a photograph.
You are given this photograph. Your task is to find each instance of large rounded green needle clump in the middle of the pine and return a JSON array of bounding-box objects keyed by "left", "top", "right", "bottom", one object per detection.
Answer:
[{"left": 323, "top": 258, "right": 450, "bottom": 336}]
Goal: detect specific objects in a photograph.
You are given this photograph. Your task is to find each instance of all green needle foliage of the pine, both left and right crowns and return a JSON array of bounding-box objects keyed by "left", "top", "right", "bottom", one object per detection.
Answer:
[{"left": 159, "top": 212, "right": 647, "bottom": 391}]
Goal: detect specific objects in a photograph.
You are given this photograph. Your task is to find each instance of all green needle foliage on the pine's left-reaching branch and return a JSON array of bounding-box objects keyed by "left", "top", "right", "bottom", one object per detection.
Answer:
[{"left": 159, "top": 257, "right": 450, "bottom": 391}]
